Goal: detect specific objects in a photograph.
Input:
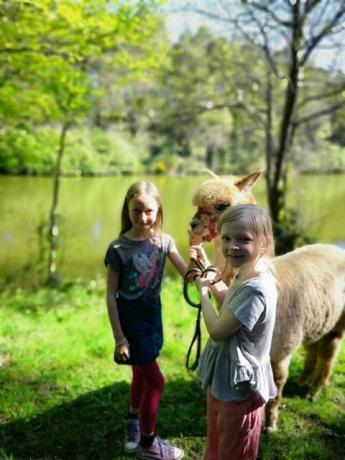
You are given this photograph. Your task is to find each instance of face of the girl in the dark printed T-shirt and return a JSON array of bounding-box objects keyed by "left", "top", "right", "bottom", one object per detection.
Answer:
[{"left": 128, "top": 193, "right": 158, "bottom": 233}]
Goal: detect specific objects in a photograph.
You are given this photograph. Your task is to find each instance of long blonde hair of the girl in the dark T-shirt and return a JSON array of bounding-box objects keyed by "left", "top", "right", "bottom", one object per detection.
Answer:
[{"left": 120, "top": 180, "right": 163, "bottom": 236}]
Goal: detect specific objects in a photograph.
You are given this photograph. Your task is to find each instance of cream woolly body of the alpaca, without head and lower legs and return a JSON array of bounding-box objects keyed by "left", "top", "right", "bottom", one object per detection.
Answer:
[{"left": 271, "top": 244, "right": 345, "bottom": 361}]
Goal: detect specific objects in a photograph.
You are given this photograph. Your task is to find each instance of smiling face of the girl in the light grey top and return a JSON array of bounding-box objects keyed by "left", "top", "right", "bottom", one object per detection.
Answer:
[{"left": 221, "top": 219, "right": 260, "bottom": 268}]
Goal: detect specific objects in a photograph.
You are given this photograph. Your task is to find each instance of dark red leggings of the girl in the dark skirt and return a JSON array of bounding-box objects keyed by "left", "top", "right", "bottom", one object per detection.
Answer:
[{"left": 130, "top": 360, "right": 164, "bottom": 434}]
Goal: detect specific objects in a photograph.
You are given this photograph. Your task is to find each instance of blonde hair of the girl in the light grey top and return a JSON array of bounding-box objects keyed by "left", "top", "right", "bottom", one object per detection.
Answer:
[{"left": 217, "top": 204, "right": 274, "bottom": 274}]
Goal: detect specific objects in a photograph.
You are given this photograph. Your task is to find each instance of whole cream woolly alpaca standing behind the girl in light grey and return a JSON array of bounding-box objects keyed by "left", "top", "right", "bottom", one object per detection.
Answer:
[{"left": 190, "top": 171, "right": 345, "bottom": 431}]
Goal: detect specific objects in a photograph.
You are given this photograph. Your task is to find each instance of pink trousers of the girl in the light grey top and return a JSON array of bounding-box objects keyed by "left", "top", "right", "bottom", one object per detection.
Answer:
[{"left": 204, "top": 391, "right": 264, "bottom": 460}]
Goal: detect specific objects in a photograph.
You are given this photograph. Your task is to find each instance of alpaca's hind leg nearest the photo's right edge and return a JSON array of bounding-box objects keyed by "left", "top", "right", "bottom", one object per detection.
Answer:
[{"left": 308, "top": 330, "right": 344, "bottom": 400}]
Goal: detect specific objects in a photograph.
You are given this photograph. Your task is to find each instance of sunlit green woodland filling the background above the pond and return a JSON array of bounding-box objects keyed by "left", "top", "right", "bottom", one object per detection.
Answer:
[{"left": 0, "top": 0, "right": 345, "bottom": 176}]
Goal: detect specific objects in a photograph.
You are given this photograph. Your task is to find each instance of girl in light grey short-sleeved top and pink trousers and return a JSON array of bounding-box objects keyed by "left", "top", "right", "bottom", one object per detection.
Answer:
[{"left": 190, "top": 204, "right": 277, "bottom": 460}]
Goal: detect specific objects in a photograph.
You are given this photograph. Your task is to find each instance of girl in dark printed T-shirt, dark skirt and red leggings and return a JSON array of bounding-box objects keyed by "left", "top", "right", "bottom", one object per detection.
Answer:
[{"left": 105, "top": 181, "right": 186, "bottom": 460}]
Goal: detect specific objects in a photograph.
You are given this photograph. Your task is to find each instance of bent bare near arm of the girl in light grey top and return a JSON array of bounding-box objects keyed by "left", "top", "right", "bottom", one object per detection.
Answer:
[{"left": 197, "top": 279, "right": 242, "bottom": 342}]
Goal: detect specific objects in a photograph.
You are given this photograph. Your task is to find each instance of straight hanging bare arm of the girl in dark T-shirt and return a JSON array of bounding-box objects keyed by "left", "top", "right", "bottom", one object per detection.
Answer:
[{"left": 107, "top": 267, "right": 130, "bottom": 361}]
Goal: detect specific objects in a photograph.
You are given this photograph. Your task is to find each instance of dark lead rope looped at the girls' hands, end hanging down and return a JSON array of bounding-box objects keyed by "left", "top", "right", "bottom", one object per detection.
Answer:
[{"left": 183, "top": 260, "right": 220, "bottom": 371}]
